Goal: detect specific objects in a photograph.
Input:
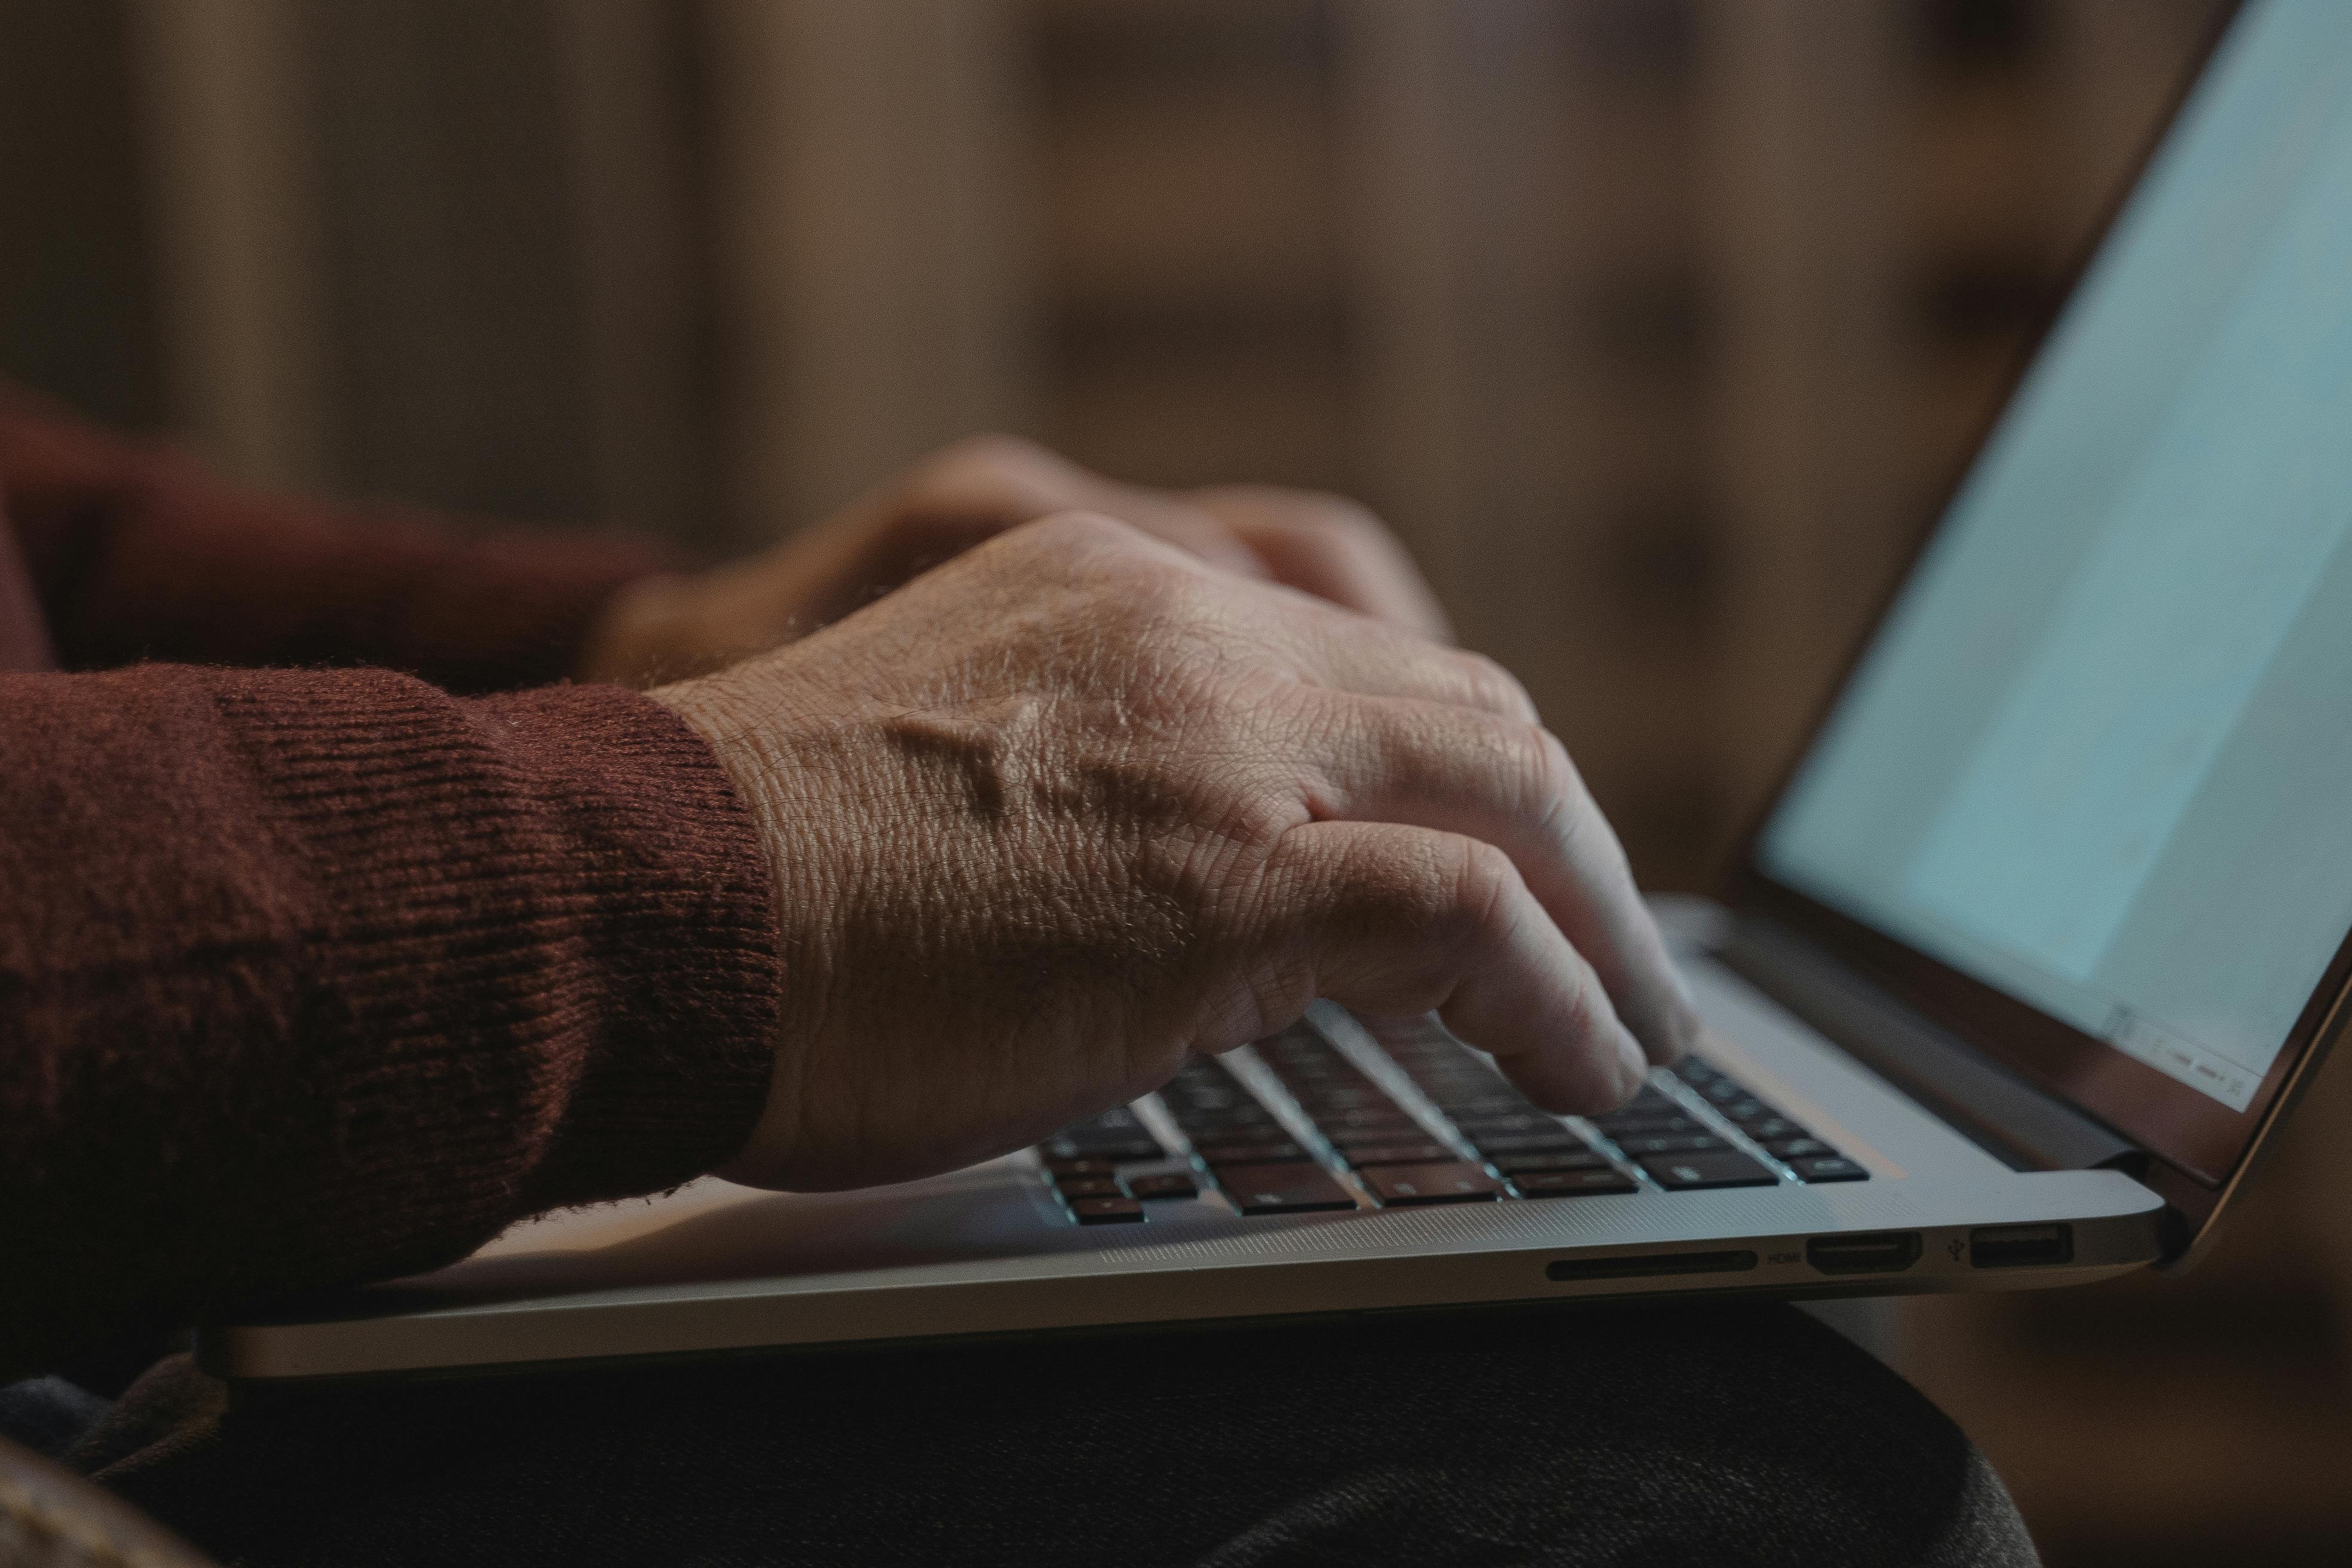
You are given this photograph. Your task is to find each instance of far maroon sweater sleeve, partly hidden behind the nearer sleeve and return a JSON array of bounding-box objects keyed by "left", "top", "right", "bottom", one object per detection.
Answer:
[{"left": 0, "top": 385, "right": 675, "bottom": 691}]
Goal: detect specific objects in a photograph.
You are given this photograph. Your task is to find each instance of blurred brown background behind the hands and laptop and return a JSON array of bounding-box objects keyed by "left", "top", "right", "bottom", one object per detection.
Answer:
[{"left": 0, "top": 0, "right": 2352, "bottom": 1566}]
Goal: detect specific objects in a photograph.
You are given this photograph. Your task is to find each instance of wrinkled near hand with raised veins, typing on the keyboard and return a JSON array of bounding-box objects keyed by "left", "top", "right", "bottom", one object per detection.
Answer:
[{"left": 654, "top": 515, "right": 1696, "bottom": 1190}]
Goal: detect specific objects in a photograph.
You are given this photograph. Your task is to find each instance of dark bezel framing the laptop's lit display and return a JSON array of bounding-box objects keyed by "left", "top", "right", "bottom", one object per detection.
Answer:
[{"left": 1731, "top": 0, "right": 2352, "bottom": 1190}]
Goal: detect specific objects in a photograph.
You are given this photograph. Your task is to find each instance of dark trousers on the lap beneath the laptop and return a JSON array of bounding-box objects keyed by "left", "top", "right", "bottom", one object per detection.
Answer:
[{"left": 73, "top": 1302, "right": 2035, "bottom": 1568}]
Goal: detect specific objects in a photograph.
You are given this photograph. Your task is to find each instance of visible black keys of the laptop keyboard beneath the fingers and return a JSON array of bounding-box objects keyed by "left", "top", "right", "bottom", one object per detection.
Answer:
[{"left": 1037, "top": 1022, "right": 1870, "bottom": 1225}]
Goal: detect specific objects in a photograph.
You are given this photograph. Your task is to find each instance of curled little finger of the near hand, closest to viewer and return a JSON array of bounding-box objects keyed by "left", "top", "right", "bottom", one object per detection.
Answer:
[{"left": 1268, "top": 823, "right": 1649, "bottom": 1112}]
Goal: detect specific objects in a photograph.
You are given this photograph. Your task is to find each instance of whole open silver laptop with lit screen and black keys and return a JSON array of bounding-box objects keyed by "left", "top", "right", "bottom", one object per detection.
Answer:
[{"left": 198, "top": 0, "right": 2352, "bottom": 1382}]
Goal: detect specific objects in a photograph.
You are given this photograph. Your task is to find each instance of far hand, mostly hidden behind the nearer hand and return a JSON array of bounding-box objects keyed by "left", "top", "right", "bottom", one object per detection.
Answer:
[{"left": 581, "top": 435, "right": 1449, "bottom": 684}]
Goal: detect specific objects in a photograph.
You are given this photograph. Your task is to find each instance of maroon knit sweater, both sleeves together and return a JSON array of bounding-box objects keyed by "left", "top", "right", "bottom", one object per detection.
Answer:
[{"left": 0, "top": 390, "right": 779, "bottom": 1380}]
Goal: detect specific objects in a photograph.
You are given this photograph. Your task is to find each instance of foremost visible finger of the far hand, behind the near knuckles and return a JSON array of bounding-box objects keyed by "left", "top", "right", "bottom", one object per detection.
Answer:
[{"left": 1188, "top": 484, "right": 1453, "bottom": 642}]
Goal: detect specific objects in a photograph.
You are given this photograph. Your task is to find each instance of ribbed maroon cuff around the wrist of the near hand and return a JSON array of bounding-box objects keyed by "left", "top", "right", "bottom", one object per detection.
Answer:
[{"left": 219, "top": 672, "right": 781, "bottom": 1260}]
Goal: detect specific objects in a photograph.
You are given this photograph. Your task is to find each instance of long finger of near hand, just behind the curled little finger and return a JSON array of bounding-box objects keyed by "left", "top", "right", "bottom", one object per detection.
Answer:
[{"left": 1305, "top": 698, "right": 1698, "bottom": 1062}]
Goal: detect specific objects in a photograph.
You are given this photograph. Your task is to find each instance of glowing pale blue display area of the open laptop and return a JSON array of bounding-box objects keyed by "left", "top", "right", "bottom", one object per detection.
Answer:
[{"left": 1757, "top": 0, "right": 2352, "bottom": 1175}]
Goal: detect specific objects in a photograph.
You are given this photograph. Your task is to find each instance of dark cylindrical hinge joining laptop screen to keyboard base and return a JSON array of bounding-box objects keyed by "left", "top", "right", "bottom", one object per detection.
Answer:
[{"left": 1717, "top": 914, "right": 2148, "bottom": 1178}]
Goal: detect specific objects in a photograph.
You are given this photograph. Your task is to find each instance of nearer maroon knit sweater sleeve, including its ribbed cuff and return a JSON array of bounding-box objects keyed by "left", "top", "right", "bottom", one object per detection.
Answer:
[{"left": 0, "top": 665, "right": 781, "bottom": 1380}]
